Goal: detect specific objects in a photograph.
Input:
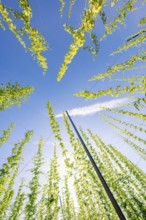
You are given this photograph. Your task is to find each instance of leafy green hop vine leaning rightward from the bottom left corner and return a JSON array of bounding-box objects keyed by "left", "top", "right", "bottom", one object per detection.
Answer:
[{"left": 0, "top": 131, "right": 33, "bottom": 219}]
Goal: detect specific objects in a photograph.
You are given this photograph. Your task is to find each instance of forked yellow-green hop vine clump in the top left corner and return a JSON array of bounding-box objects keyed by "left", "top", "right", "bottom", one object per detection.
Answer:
[{"left": 0, "top": 0, "right": 48, "bottom": 72}]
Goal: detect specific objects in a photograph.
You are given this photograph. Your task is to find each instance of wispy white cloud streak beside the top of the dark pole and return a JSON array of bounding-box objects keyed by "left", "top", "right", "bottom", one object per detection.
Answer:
[{"left": 55, "top": 98, "right": 133, "bottom": 118}]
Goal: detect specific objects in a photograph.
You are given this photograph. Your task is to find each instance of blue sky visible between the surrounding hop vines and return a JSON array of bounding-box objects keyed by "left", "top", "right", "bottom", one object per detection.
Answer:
[{"left": 0, "top": 0, "right": 146, "bottom": 186}]
